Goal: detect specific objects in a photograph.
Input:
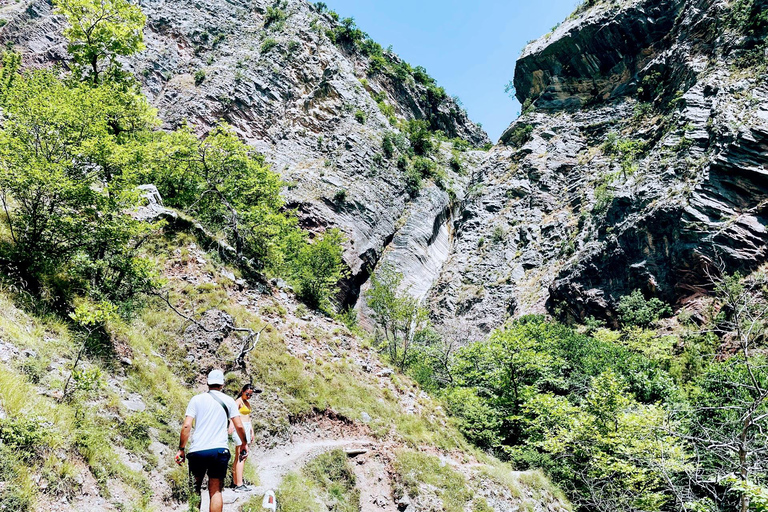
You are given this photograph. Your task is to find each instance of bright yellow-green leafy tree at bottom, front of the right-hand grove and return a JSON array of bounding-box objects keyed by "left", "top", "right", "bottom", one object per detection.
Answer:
[{"left": 526, "top": 371, "right": 686, "bottom": 512}]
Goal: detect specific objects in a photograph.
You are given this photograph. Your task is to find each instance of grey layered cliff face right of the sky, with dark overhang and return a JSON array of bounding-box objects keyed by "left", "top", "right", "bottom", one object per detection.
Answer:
[{"left": 431, "top": 0, "right": 768, "bottom": 329}]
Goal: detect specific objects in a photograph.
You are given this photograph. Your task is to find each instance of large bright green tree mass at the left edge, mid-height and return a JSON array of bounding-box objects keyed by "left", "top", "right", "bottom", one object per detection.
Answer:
[{"left": 0, "top": 71, "right": 156, "bottom": 310}]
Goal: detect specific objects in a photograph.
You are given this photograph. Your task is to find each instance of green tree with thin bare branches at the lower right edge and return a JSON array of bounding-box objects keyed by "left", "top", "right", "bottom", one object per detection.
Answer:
[{"left": 685, "top": 273, "right": 768, "bottom": 512}]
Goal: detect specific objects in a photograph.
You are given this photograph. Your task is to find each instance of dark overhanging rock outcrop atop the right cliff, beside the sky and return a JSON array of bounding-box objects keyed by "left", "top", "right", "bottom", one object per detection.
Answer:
[{"left": 514, "top": 0, "right": 684, "bottom": 110}]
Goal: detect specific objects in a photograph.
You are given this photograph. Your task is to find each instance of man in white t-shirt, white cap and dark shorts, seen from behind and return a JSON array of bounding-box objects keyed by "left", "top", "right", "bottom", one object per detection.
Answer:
[{"left": 176, "top": 370, "right": 248, "bottom": 512}]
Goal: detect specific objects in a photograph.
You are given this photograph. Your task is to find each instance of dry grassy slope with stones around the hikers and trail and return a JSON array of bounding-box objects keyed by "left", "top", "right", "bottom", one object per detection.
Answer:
[{"left": 0, "top": 229, "right": 568, "bottom": 511}]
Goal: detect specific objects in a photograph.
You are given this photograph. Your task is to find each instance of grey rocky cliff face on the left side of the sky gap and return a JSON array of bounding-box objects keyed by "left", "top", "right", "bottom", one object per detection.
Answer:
[{"left": 0, "top": 0, "right": 488, "bottom": 304}]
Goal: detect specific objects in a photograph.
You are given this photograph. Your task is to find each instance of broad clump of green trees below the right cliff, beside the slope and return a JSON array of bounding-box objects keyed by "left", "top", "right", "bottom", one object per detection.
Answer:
[{"left": 438, "top": 317, "right": 684, "bottom": 510}]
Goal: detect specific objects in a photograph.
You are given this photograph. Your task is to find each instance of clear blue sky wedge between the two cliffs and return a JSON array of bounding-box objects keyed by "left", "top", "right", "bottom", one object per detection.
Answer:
[{"left": 325, "top": 0, "right": 577, "bottom": 141}]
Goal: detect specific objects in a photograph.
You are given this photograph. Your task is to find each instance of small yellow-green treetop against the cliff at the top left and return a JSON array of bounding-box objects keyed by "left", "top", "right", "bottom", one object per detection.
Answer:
[{"left": 54, "top": 0, "right": 147, "bottom": 84}]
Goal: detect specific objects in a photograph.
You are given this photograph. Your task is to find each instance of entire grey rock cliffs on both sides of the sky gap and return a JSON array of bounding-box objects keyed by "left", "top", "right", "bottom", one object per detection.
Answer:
[{"left": 2, "top": 0, "right": 768, "bottom": 331}]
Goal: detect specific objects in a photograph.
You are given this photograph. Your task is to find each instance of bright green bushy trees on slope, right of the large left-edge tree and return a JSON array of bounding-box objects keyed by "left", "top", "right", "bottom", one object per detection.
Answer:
[{"left": 144, "top": 125, "right": 305, "bottom": 274}]
